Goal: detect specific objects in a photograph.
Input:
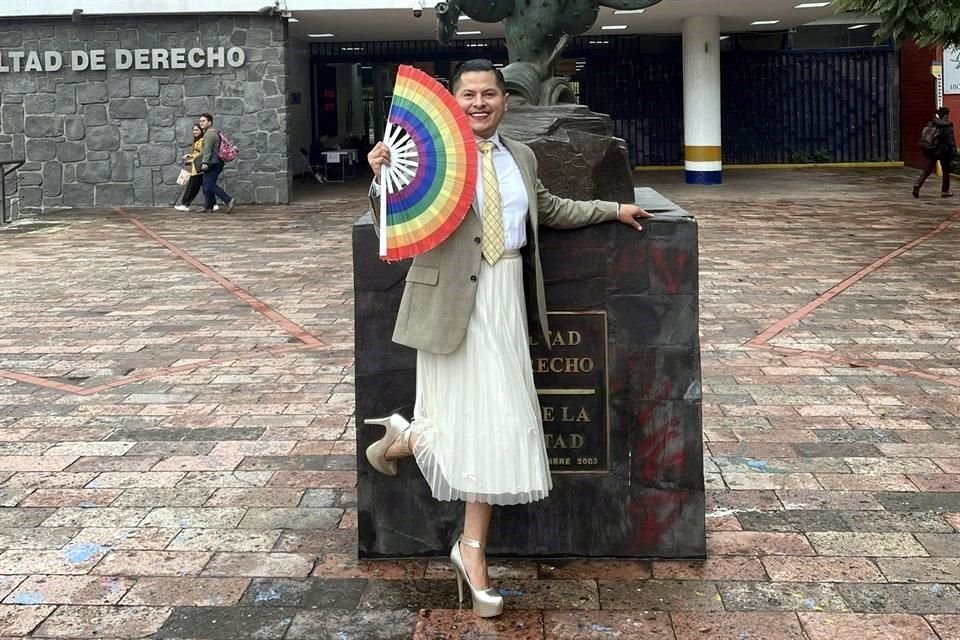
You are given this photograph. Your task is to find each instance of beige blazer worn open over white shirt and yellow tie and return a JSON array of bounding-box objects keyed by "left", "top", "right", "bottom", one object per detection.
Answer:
[{"left": 370, "top": 135, "right": 619, "bottom": 354}]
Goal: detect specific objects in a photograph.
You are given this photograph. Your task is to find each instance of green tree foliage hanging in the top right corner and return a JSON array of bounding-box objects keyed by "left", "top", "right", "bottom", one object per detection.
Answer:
[{"left": 833, "top": 0, "right": 960, "bottom": 46}]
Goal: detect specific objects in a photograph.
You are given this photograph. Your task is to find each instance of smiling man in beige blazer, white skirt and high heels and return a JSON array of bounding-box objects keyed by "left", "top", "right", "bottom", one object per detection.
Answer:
[{"left": 367, "top": 60, "right": 651, "bottom": 617}]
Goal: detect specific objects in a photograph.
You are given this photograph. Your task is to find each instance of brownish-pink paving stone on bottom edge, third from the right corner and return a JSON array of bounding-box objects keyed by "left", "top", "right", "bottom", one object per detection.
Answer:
[{"left": 670, "top": 613, "right": 807, "bottom": 640}]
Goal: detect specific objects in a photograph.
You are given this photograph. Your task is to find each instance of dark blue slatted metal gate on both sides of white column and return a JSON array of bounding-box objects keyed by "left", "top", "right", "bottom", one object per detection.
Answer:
[{"left": 578, "top": 48, "right": 899, "bottom": 165}]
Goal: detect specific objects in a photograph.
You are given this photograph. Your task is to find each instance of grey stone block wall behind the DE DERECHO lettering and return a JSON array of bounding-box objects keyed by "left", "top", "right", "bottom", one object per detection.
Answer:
[{"left": 0, "top": 15, "right": 290, "bottom": 213}]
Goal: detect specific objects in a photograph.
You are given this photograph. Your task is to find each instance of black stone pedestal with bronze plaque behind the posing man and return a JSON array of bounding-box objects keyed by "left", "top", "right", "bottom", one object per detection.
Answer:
[{"left": 353, "top": 189, "right": 706, "bottom": 558}]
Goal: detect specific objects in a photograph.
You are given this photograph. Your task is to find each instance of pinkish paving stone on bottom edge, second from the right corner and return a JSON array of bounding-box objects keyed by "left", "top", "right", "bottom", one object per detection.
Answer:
[{"left": 799, "top": 613, "right": 937, "bottom": 640}]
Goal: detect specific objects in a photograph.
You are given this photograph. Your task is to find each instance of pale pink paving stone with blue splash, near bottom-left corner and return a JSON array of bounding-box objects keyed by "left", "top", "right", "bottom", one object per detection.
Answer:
[{"left": 4, "top": 576, "right": 134, "bottom": 605}]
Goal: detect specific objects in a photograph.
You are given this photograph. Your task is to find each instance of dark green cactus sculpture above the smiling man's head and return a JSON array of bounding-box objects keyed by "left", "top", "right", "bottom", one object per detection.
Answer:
[{"left": 435, "top": 0, "right": 661, "bottom": 105}]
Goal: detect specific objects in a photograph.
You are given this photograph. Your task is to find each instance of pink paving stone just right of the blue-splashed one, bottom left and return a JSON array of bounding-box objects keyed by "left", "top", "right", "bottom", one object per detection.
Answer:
[{"left": 122, "top": 577, "right": 250, "bottom": 607}]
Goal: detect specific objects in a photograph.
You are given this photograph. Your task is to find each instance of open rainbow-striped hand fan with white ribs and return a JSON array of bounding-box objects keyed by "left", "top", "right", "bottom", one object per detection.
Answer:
[{"left": 380, "top": 65, "right": 477, "bottom": 261}]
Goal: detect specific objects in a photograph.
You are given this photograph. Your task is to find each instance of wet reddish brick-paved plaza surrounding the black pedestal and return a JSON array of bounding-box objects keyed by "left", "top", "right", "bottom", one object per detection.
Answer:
[{"left": 0, "top": 170, "right": 960, "bottom": 640}]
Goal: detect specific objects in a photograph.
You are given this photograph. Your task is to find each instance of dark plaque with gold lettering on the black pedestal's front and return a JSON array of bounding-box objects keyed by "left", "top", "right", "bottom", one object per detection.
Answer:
[{"left": 530, "top": 311, "right": 610, "bottom": 473}]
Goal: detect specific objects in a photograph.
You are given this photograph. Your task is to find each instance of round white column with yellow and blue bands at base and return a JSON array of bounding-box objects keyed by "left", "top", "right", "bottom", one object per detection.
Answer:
[{"left": 683, "top": 16, "right": 723, "bottom": 184}]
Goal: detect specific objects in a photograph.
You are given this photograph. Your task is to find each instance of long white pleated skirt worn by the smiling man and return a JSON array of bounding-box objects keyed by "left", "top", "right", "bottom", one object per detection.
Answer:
[{"left": 413, "top": 253, "right": 553, "bottom": 505}]
